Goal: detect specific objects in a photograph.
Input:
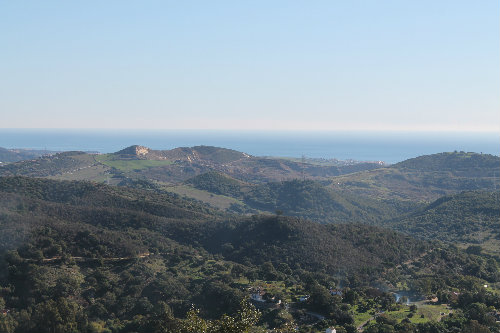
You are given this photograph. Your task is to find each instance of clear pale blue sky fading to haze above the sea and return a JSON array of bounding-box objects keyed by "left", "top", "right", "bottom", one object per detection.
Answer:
[{"left": 0, "top": 0, "right": 500, "bottom": 131}]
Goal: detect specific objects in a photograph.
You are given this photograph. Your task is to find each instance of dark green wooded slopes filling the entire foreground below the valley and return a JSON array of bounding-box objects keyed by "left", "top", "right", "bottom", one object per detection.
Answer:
[{"left": 0, "top": 177, "right": 500, "bottom": 332}]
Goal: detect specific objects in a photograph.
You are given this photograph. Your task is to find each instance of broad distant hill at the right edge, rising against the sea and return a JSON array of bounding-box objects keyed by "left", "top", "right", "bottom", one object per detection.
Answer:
[{"left": 330, "top": 152, "right": 500, "bottom": 202}]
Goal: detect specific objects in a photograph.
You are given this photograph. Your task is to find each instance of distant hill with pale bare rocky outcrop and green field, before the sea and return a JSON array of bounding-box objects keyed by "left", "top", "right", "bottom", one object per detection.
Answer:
[{"left": 97, "top": 146, "right": 381, "bottom": 184}]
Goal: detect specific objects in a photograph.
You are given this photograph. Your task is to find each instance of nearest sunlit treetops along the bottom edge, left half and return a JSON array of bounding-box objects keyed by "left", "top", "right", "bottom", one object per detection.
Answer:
[{"left": 0, "top": 298, "right": 264, "bottom": 333}]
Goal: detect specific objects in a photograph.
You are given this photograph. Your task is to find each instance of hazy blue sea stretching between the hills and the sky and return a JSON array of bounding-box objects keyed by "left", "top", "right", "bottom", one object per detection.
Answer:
[{"left": 0, "top": 129, "right": 500, "bottom": 163}]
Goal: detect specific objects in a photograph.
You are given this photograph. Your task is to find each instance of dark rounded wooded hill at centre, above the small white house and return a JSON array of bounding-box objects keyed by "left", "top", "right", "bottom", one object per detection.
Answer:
[{"left": 186, "top": 216, "right": 429, "bottom": 280}]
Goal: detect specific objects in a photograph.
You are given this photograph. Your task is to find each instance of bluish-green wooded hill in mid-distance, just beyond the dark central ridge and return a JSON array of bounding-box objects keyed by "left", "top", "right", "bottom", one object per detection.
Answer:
[{"left": 186, "top": 172, "right": 418, "bottom": 224}]
